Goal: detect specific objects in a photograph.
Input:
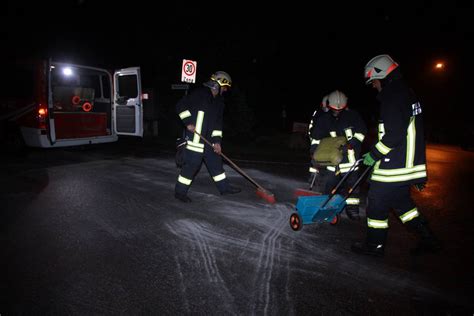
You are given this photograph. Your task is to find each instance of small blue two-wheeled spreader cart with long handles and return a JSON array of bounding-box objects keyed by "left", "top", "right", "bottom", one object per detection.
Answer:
[{"left": 290, "top": 159, "right": 372, "bottom": 231}]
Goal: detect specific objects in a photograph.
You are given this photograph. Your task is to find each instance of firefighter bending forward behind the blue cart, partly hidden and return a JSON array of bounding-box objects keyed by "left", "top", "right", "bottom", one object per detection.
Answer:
[{"left": 311, "top": 90, "right": 367, "bottom": 220}]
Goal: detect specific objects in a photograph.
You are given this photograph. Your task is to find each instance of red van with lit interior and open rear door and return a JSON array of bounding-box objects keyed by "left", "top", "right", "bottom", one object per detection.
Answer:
[{"left": 0, "top": 60, "right": 143, "bottom": 150}]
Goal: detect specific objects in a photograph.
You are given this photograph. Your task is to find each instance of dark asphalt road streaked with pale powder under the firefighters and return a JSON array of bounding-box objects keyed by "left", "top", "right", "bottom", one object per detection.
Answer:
[{"left": 0, "top": 144, "right": 474, "bottom": 316}]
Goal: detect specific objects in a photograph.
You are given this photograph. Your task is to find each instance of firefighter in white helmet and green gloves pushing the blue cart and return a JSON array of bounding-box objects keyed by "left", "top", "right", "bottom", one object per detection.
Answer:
[{"left": 352, "top": 55, "right": 440, "bottom": 256}]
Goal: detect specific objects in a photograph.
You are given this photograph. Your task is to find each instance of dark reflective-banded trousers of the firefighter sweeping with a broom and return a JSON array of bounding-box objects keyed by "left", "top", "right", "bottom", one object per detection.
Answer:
[{"left": 175, "top": 147, "right": 229, "bottom": 195}]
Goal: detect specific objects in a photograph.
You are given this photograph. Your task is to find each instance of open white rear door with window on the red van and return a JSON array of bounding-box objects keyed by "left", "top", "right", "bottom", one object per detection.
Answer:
[{"left": 113, "top": 67, "right": 143, "bottom": 137}]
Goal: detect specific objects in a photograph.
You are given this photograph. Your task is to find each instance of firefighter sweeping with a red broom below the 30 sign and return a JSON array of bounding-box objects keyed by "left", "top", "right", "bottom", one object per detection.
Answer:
[{"left": 175, "top": 71, "right": 241, "bottom": 203}]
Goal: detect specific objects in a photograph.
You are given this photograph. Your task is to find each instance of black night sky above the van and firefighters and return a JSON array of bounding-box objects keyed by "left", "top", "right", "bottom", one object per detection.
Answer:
[{"left": 0, "top": 0, "right": 474, "bottom": 136}]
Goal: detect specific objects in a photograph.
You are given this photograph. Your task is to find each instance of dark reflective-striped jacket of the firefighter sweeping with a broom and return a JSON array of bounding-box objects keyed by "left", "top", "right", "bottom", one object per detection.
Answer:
[{"left": 176, "top": 87, "right": 224, "bottom": 153}]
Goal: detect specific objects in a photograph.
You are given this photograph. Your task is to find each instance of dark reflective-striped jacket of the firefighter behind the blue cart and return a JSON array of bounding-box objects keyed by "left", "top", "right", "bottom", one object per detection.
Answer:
[{"left": 311, "top": 109, "right": 367, "bottom": 173}]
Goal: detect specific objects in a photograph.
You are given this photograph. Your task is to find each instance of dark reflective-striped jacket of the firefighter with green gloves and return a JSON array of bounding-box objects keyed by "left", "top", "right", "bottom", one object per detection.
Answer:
[{"left": 370, "top": 78, "right": 427, "bottom": 184}]
